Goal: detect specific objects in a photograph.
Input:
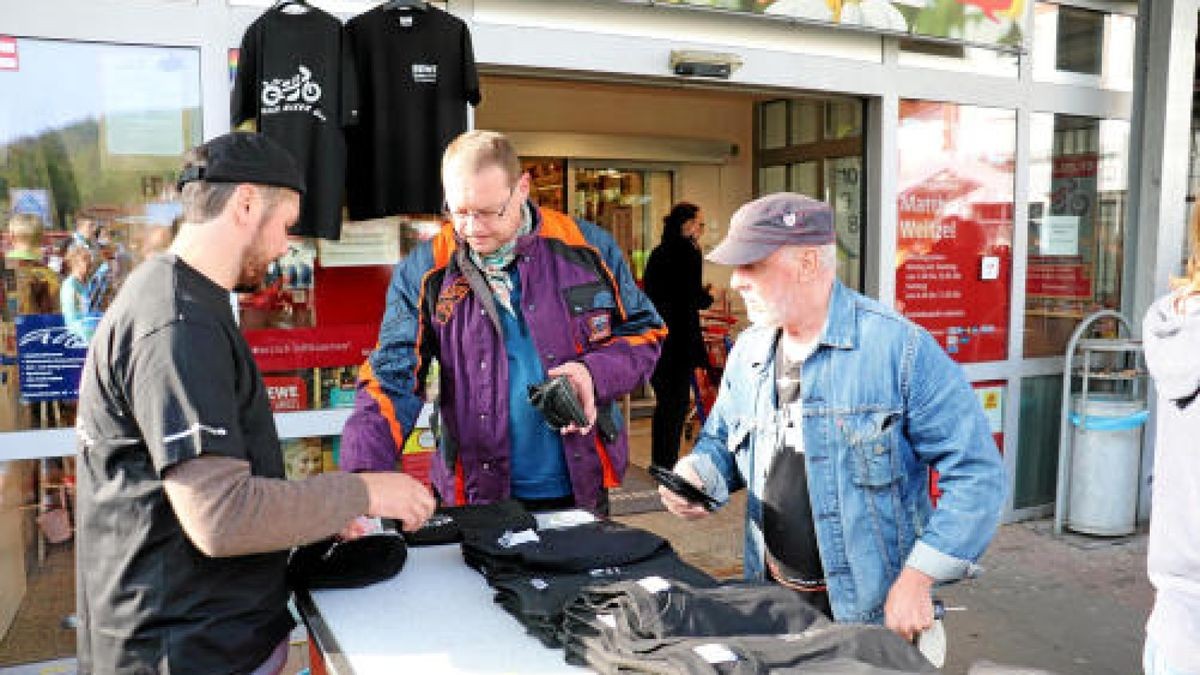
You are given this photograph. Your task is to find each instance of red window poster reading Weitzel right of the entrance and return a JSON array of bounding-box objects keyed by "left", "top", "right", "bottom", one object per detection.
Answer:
[{"left": 896, "top": 101, "right": 1016, "bottom": 363}]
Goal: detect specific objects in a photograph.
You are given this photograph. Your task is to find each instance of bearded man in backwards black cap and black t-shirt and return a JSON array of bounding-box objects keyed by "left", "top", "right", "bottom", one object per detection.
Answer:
[{"left": 76, "top": 133, "right": 433, "bottom": 674}]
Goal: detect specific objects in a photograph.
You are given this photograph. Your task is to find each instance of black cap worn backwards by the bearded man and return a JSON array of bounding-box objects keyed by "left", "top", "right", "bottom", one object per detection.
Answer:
[{"left": 178, "top": 131, "right": 305, "bottom": 195}]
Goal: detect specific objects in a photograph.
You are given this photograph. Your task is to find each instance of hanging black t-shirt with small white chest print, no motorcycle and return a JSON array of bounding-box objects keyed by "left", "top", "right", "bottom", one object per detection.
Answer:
[{"left": 346, "top": 6, "right": 480, "bottom": 220}]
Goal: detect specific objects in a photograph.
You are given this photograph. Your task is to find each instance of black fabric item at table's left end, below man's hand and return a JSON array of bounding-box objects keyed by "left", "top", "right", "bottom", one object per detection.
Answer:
[{"left": 288, "top": 533, "right": 408, "bottom": 590}]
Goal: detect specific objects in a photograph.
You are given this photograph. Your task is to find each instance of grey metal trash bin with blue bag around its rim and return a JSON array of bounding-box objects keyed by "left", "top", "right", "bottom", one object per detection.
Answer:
[{"left": 1066, "top": 394, "right": 1150, "bottom": 537}]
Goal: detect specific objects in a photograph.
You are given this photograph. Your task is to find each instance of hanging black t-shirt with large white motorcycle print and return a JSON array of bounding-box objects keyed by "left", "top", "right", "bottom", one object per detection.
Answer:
[{"left": 230, "top": 7, "right": 359, "bottom": 239}]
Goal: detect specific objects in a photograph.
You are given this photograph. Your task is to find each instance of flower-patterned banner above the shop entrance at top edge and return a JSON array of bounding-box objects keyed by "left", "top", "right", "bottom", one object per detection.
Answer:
[{"left": 667, "top": 0, "right": 1026, "bottom": 49}]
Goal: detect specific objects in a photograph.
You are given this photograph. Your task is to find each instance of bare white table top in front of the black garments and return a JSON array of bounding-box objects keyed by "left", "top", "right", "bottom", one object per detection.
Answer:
[{"left": 298, "top": 544, "right": 588, "bottom": 675}]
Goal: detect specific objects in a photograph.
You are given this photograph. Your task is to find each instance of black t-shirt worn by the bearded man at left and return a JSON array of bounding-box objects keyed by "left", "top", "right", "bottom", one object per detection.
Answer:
[{"left": 76, "top": 253, "right": 294, "bottom": 675}]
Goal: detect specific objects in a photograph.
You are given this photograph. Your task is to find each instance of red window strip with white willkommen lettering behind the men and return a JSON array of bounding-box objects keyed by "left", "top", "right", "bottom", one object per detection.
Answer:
[{"left": 245, "top": 324, "right": 379, "bottom": 372}]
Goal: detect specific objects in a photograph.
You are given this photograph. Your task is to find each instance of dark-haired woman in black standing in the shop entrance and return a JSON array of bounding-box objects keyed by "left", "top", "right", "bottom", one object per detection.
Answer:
[{"left": 643, "top": 202, "right": 713, "bottom": 468}]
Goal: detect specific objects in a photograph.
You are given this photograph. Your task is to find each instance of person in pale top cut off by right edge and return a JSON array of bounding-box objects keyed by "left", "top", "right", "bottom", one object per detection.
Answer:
[{"left": 1141, "top": 209, "right": 1200, "bottom": 675}]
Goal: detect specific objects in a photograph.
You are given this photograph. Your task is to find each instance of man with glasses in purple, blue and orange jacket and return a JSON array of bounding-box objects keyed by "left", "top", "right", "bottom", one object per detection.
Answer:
[{"left": 341, "top": 131, "right": 666, "bottom": 514}]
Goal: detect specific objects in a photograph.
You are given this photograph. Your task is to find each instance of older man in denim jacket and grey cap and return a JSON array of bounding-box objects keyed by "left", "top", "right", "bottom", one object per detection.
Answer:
[{"left": 659, "top": 193, "right": 1006, "bottom": 639}]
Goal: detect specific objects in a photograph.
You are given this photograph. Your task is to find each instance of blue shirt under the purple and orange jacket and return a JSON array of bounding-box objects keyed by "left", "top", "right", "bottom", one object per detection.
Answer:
[{"left": 496, "top": 267, "right": 571, "bottom": 500}]
